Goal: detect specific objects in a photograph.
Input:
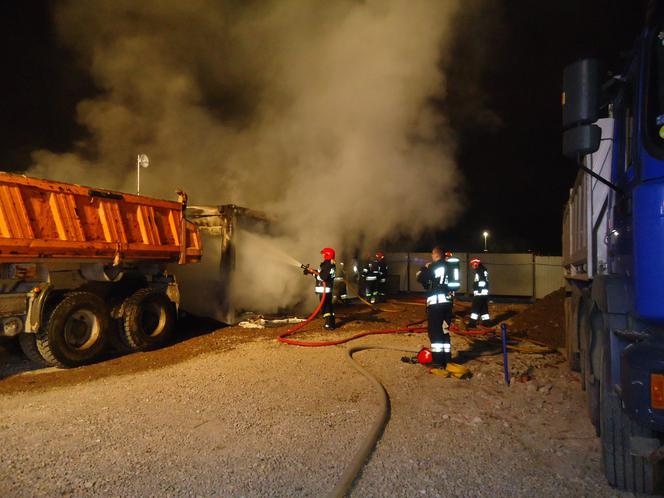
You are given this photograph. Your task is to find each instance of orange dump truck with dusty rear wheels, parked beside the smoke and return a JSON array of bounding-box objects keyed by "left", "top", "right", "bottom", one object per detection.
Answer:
[{"left": 0, "top": 173, "right": 201, "bottom": 367}]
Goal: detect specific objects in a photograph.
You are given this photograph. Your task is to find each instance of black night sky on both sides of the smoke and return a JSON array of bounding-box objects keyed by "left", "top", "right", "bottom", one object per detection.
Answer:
[{"left": 0, "top": 0, "right": 645, "bottom": 254}]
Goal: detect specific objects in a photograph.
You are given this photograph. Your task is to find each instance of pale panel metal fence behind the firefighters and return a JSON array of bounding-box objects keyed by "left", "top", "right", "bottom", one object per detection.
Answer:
[{"left": 385, "top": 252, "right": 564, "bottom": 299}]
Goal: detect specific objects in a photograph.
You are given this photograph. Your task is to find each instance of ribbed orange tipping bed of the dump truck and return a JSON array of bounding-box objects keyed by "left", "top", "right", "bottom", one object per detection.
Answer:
[{"left": 0, "top": 172, "right": 201, "bottom": 263}]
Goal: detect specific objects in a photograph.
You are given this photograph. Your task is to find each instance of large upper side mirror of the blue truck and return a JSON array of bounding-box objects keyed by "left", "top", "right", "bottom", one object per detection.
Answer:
[{"left": 562, "top": 59, "right": 600, "bottom": 130}]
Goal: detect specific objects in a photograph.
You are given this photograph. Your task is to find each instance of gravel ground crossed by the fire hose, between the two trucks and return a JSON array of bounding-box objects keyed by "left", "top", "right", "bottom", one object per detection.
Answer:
[{"left": 0, "top": 306, "right": 626, "bottom": 497}]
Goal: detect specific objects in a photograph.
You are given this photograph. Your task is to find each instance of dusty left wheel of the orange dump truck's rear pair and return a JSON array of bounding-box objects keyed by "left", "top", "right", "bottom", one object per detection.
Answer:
[{"left": 36, "top": 292, "right": 110, "bottom": 367}]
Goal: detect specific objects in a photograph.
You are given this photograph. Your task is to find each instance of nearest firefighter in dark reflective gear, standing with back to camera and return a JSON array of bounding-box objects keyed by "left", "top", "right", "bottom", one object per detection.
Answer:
[{"left": 417, "top": 247, "right": 452, "bottom": 368}]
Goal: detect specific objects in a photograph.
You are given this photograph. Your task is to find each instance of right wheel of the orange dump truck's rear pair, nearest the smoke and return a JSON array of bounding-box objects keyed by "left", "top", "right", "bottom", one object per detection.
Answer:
[{"left": 122, "top": 288, "right": 177, "bottom": 351}]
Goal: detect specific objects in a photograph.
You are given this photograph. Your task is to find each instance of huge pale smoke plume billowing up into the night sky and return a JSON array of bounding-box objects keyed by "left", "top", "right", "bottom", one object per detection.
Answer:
[{"left": 29, "top": 0, "right": 460, "bottom": 314}]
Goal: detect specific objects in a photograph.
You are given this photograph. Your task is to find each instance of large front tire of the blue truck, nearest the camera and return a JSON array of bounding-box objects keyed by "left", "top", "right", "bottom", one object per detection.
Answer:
[{"left": 600, "top": 349, "right": 663, "bottom": 494}]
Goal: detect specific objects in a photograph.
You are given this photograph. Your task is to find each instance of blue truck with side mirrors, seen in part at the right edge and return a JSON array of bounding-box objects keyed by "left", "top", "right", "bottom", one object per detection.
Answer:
[{"left": 562, "top": 4, "right": 664, "bottom": 493}]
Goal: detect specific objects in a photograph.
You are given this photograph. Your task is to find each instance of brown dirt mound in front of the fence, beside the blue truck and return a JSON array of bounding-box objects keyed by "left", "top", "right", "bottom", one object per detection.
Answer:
[{"left": 508, "top": 287, "right": 565, "bottom": 348}]
